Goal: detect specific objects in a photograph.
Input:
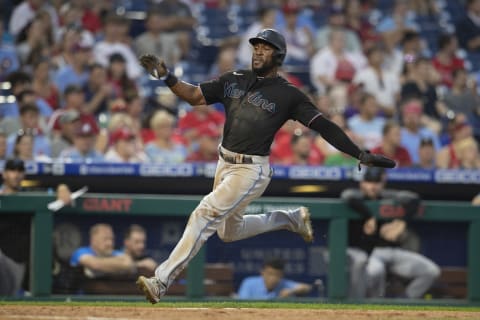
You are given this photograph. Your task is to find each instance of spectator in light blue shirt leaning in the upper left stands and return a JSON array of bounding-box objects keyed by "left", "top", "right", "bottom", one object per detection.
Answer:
[{"left": 53, "top": 36, "right": 92, "bottom": 93}]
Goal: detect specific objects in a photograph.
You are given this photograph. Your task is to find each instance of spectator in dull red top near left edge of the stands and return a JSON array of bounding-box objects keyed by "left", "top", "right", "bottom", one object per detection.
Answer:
[{"left": 32, "top": 58, "right": 60, "bottom": 110}]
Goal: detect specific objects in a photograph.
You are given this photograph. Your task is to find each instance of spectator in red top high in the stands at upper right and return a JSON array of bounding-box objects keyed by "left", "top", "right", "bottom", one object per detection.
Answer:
[{"left": 432, "top": 34, "right": 465, "bottom": 88}]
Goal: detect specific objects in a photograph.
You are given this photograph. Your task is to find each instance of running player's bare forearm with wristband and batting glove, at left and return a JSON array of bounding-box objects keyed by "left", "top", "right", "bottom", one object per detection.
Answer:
[{"left": 139, "top": 54, "right": 206, "bottom": 106}]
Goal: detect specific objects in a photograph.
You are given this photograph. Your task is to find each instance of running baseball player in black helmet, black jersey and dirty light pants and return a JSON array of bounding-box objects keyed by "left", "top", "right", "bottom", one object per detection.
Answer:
[{"left": 137, "top": 29, "right": 395, "bottom": 303}]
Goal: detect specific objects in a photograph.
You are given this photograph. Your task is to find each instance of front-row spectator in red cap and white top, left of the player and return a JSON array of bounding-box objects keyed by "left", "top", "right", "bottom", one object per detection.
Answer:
[{"left": 105, "top": 127, "right": 148, "bottom": 163}]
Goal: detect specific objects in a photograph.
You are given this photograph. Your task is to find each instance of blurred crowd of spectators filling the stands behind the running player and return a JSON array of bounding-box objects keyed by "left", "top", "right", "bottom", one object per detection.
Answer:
[{"left": 0, "top": 0, "right": 480, "bottom": 169}]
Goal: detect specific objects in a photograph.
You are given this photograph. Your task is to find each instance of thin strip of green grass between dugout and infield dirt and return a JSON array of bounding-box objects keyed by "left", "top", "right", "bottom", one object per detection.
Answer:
[{"left": 0, "top": 300, "right": 480, "bottom": 312}]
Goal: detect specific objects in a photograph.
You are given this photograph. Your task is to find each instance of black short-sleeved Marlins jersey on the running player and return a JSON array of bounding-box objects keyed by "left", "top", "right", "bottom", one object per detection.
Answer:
[{"left": 200, "top": 70, "right": 320, "bottom": 156}]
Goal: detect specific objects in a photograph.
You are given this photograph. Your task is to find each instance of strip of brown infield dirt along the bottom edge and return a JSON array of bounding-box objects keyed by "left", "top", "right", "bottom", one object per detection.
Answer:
[{"left": 0, "top": 305, "right": 480, "bottom": 320}]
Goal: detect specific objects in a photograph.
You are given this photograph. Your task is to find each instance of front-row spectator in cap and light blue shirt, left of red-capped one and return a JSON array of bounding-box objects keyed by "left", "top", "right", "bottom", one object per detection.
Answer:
[{"left": 59, "top": 123, "right": 105, "bottom": 163}]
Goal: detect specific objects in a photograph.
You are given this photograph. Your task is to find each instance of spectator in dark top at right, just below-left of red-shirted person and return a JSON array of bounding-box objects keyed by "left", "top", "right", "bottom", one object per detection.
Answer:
[{"left": 401, "top": 58, "right": 446, "bottom": 134}]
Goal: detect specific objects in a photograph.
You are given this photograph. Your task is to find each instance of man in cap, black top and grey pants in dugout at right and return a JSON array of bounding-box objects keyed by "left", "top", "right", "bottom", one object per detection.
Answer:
[{"left": 341, "top": 167, "right": 440, "bottom": 299}]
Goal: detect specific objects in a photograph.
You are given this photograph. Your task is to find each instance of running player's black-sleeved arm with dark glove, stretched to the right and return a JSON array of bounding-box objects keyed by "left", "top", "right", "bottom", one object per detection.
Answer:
[{"left": 309, "top": 115, "right": 396, "bottom": 168}]
